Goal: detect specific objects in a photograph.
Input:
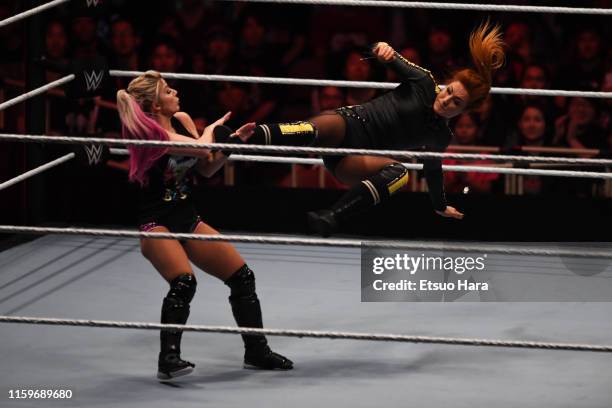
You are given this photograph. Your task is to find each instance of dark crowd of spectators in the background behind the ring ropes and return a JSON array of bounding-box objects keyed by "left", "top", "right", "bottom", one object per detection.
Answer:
[{"left": 0, "top": 0, "right": 612, "bottom": 192}]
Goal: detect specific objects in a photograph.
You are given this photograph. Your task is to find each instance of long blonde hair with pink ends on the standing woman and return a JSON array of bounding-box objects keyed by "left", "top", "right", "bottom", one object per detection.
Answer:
[{"left": 117, "top": 71, "right": 170, "bottom": 185}]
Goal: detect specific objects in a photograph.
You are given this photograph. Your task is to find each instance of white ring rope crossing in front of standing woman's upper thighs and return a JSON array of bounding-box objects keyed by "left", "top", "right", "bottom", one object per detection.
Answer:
[{"left": 0, "top": 225, "right": 612, "bottom": 259}]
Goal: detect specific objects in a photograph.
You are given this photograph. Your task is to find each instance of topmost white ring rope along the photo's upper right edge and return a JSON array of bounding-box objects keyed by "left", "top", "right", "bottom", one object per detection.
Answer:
[{"left": 216, "top": 0, "right": 612, "bottom": 15}]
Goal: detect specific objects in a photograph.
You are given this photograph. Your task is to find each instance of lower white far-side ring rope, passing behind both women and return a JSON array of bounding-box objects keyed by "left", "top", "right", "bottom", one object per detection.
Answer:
[{"left": 109, "top": 148, "right": 612, "bottom": 179}]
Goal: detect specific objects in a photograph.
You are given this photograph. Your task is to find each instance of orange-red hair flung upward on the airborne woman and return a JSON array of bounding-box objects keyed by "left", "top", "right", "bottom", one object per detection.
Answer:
[{"left": 453, "top": 20, "right": 505, "bottom": 109}]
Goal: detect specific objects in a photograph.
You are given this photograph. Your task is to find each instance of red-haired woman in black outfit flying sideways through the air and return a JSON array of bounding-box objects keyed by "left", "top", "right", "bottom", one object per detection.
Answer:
[{"left": 218, "top": 22, "right": 504, "bottom": 236}]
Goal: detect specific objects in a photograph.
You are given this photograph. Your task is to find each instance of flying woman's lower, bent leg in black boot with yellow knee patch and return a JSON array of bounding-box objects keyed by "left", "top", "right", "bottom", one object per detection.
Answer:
[{"left": 308, "top": 163, "right": 408, "bottom": 237}]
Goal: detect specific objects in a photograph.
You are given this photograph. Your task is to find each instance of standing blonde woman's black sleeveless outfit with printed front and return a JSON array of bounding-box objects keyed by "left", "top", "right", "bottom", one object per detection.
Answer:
[{"left": 138, "top": 117, "right": 199, "bottom": 224}]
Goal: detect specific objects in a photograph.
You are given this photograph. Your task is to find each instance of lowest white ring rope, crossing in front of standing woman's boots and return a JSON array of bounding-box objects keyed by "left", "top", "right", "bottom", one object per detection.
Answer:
[{"left": 0, "top": 316, "right": 612, "bottom": 353}]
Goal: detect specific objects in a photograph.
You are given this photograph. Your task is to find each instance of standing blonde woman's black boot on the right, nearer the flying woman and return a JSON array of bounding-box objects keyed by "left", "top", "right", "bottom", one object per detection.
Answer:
[{"left": 225, "top": 264, "right": 293, "bottom": 370}]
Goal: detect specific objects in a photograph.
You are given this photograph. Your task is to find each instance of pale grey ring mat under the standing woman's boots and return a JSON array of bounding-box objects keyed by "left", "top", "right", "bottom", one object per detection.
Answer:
[{"left": 0, "top": 236, "right": 612, "bottom": 408}]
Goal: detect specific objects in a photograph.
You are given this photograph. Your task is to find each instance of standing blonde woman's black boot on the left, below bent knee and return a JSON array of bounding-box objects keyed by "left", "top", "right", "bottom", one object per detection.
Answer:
[{"left": 157, "top": 274, "right": 197, "bottom": 380}]
